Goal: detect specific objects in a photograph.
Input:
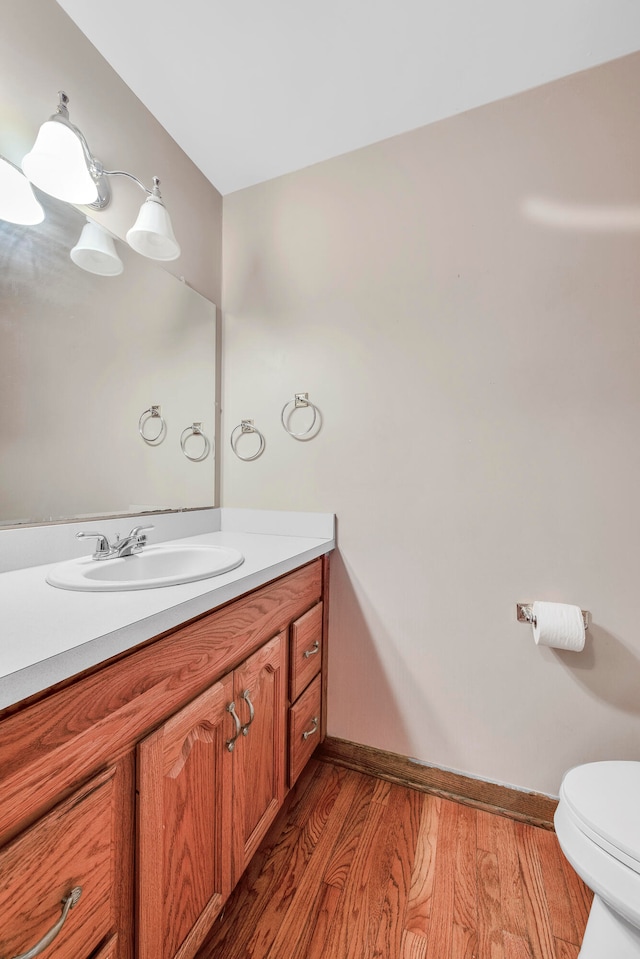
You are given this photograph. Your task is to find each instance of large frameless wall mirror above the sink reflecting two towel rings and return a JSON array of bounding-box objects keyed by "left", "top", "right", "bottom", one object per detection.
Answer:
[{"left": 0, "top": 184, "right": 216, "bottom": 527}]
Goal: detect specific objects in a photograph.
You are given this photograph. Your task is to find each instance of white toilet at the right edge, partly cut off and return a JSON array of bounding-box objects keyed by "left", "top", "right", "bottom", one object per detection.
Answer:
[{"left": 554, "top": 761, "right": 640, "bottom": 959}]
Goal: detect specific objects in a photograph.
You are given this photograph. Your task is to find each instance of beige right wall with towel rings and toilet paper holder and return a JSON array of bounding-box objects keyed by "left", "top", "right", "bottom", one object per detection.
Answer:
[{"left": 221, "top": 55, "right": 640, "bottom": 793}]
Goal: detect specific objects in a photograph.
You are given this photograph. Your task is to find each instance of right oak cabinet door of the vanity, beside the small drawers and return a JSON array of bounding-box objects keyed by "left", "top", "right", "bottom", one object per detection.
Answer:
[{"left": 233, "top": 631, "right": 287, "bottom": 885}]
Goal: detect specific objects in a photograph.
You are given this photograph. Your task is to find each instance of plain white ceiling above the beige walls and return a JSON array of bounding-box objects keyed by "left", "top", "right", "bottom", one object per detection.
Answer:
[{"left": 58, "top": 0, "right": 640, "bottom": 194}]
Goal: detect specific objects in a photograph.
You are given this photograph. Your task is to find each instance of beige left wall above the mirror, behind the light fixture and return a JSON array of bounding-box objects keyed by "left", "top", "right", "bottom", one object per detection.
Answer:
[{"left": 0, "top": 0, "right": 222, "bottom": 304}]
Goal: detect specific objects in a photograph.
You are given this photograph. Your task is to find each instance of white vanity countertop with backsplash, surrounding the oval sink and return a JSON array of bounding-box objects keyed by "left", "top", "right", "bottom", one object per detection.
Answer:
[{"left": 0, "top": 509, "right": 335, "bottom": 709}]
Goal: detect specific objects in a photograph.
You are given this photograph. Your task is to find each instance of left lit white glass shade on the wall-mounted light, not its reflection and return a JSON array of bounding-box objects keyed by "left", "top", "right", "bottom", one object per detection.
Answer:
[{"left": 22, "top": 120, "right": 98, "bottom": 204}]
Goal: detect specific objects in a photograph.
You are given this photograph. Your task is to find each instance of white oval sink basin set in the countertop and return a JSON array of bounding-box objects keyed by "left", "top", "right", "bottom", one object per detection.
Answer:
[{"left": 46, "top": 546, "right": 244, "bottom": 592}]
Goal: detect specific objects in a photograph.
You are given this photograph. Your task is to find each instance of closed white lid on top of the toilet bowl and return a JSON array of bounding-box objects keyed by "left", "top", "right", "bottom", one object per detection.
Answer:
[{"left": 560, "top": 760, "right": 640, "bottom": 872}]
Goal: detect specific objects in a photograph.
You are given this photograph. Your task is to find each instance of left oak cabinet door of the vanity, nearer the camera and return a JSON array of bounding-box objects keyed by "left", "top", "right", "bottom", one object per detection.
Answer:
[{"left": 138, "top": 675, "right": 236, "bottom": 959}]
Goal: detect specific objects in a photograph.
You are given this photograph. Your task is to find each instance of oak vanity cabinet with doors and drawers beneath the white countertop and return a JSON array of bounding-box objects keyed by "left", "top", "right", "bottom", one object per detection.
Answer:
[{"left": 0, "top": 512, "right": 332, "bottom": 959}]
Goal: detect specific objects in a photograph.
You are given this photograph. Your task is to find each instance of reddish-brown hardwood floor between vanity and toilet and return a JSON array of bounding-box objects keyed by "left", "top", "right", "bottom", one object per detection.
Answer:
[{"left": 198, "top": 760, "right": 591, "bottom": 959}]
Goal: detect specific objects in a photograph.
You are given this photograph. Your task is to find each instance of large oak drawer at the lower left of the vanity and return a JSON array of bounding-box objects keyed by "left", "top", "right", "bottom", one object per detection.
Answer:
[{"left": 0, "top": 769, "right": 115, "bottom": 959}]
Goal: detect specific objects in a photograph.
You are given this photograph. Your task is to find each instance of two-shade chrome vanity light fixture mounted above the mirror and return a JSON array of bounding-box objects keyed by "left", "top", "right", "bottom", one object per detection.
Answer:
[{"left": 22, "top": 91, "right": 180, "bottom": 260}]
